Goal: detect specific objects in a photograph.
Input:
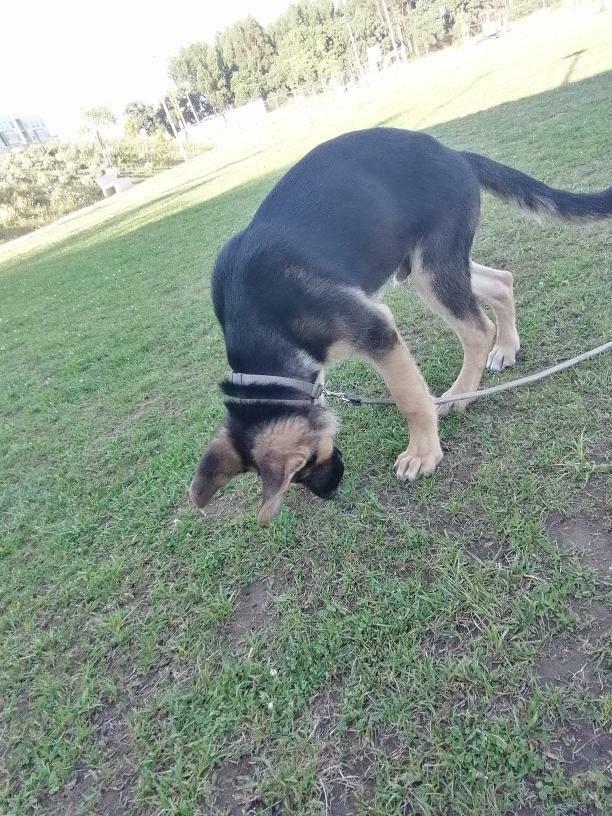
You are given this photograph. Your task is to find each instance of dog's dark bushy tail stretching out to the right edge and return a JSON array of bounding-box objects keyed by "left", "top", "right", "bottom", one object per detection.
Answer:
[{"left": 461, "top": 152, "right": 612, "bottom": 222}]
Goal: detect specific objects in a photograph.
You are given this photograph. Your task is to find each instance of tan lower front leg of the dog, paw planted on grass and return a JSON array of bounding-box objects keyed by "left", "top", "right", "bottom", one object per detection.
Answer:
[{"left": 374, "top": 336, "right": 442, "bottom": 482}]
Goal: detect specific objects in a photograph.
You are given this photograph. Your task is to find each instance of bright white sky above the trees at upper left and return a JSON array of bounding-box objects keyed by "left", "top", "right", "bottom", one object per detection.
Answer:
[{"left": 0, "top": 0, "right": 291, "bottom": 136}]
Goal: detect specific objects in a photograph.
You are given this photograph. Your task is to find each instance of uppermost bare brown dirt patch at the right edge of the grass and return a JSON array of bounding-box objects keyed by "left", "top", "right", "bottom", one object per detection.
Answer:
[{"left": 546, "top": 513, "right": 612, "bottom": 580}]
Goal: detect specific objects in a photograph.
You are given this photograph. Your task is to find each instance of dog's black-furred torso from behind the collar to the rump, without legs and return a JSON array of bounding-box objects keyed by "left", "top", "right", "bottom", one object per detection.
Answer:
[{"left": 213, "top": 128, "right": 480, "bottom": 371}]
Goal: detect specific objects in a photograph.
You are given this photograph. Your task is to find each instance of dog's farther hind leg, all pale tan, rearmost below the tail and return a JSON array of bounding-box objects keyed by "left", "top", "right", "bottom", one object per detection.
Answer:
[{"left": 472, "top": 261, "right": 521, "bottom": 371}]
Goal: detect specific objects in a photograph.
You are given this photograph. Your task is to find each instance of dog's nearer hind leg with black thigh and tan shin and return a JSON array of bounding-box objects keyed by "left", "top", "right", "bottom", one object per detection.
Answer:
[{"left": 411, "top": 249, "right": 495, "bottom": 416}]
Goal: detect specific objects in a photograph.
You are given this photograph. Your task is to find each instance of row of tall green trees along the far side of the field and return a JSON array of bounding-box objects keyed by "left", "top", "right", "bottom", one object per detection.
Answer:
[{"left": 126, "top": 0, "right": 542, "bottom": 134}]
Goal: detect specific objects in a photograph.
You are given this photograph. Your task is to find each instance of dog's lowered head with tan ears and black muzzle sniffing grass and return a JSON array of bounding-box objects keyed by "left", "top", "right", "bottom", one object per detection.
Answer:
[{"left": 189, "top": 405, "right": 344, "bottom": 524}]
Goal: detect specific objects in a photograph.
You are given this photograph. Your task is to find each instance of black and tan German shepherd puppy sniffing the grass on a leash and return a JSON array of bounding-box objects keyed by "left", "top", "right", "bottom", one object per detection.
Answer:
[{"left": 190, "top": 128, "right": 612, "bottom": 523}]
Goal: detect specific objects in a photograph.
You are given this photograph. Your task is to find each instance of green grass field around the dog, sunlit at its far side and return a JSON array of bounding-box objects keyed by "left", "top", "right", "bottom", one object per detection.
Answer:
[{"left": 0, "top": 6, "right": 612, "bottom": 816}]
